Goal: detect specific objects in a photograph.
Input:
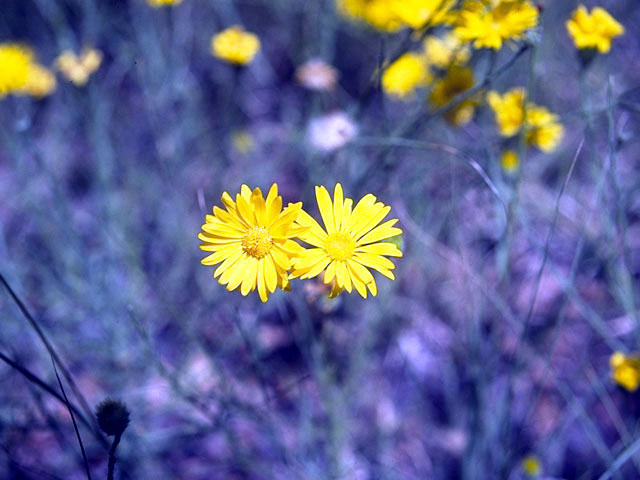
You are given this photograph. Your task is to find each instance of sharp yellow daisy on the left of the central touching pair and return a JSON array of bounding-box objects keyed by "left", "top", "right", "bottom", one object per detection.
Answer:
[{"left": 198, "top": 183, "right": 305, "bottom": 302}]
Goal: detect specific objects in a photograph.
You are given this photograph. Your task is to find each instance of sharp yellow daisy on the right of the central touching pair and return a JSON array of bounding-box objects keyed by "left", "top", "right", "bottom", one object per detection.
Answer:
[{"left": 291, "top": 183, "right": 402, "bottom": 298}]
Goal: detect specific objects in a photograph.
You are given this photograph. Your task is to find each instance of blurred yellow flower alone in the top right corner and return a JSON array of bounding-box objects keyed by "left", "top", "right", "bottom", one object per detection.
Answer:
[{"left": 566, "top": 5, "right": 624, "bottom": 53}]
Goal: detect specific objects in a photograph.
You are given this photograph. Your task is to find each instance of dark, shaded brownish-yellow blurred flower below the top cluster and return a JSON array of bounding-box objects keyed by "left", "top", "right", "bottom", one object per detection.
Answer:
[{"left": 429, "top": 67, "right": 477, "bottom": 126}]
